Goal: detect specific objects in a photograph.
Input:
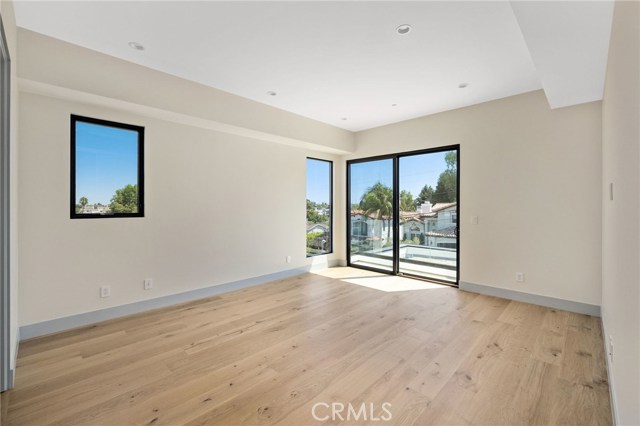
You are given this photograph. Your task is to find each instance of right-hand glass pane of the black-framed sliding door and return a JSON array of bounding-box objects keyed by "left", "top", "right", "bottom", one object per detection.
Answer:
[{"left": 398, "top": 151, "right": 458, "bottom": 282}]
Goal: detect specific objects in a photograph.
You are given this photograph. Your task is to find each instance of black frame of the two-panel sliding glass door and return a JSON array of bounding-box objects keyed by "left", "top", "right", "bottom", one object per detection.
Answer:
[{"left": 346, "top": 145, "right": 460, "bottom": 287}]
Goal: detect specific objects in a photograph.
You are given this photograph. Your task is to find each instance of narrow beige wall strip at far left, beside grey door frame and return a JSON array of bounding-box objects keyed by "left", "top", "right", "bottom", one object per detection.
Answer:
[{"left": 0, "top": 0, "right": 19, "bottom": 368}]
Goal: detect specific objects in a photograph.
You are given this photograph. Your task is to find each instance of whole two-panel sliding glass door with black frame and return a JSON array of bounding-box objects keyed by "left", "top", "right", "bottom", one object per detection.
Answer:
[{"left": 347, "top": 146, "right": 459, "bottom": 285}]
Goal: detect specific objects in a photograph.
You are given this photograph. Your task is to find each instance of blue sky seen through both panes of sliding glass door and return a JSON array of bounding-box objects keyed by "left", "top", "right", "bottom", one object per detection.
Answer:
[{"left": 351, "top": 152, "right": 447, "bottom": 203}]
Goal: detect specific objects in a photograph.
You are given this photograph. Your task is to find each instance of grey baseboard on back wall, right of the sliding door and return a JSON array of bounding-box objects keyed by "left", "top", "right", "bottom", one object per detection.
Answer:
[{"left": 459, "top": 281, "right": 600, "bottom": 317}]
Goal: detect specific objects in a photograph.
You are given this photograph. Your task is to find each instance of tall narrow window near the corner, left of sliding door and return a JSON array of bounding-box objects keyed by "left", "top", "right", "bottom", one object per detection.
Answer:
[{"left": 307, "top": 158, "right": 333, "bottom": 256}]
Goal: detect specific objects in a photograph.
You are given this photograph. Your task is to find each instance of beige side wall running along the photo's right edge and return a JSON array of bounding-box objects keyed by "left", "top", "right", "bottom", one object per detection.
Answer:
[{"left": 602, "top": 1, "right": 640, "bottom": 425}]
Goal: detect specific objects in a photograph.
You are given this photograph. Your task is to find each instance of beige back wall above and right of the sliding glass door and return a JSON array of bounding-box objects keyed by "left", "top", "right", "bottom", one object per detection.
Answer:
[{"left": 347, "top": 91, "right": 601, "bottom": 305}]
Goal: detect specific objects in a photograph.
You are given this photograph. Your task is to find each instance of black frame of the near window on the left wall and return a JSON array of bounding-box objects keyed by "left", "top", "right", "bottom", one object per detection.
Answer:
[{"left": 69, "top": 114, "right": 144, "bottom": 219}]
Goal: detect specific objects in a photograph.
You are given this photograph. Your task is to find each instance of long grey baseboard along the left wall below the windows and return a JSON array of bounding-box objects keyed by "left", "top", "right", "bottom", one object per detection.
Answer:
[{"left": 18, "top": 261, "right": 332, "bottom": 340}]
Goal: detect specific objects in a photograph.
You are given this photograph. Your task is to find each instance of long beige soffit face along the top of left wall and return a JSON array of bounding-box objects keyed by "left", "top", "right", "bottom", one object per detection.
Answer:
[{"left": 18, "top": 29, "right": 354, "bottom": 153}]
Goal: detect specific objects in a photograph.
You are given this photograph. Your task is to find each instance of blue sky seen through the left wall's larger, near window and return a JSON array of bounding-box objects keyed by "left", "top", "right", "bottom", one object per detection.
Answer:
[{"left": 76, "top": 121, "right": 138, "bottom": 204}]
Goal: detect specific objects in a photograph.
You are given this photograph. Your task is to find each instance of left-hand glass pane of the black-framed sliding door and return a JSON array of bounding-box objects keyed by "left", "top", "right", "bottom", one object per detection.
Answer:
[{"left": 349, "top": 159, "right": 394, "bottom": 271}]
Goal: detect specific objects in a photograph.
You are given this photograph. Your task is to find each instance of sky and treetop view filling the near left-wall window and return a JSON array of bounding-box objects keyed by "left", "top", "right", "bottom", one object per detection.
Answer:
[{"left": 72, "top": 117, "right": 141, "bottom": 216}]
